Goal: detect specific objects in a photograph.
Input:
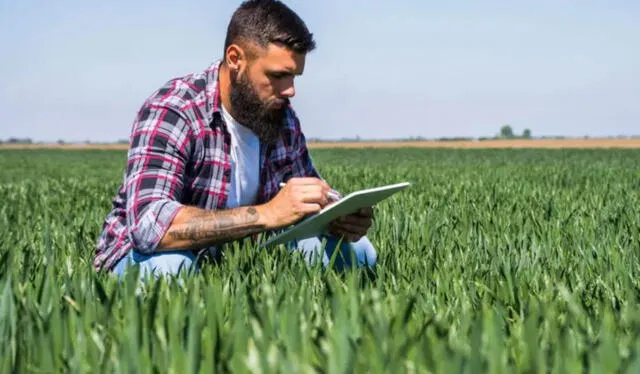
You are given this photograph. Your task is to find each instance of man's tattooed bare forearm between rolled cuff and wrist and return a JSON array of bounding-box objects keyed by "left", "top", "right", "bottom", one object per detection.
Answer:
[{"left": 169, "top": 207, "right": 264, "bottom": 247}]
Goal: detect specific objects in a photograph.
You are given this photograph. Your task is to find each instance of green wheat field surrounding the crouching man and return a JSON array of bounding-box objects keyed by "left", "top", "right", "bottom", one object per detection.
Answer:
[{"left": 0, "top": 149, "right": 640, "bottom": 373}]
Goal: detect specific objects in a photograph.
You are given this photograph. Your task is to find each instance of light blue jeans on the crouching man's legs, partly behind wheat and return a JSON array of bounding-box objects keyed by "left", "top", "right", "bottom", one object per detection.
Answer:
[{"left": 112, "top": 236, "right": 377, "bottom": 277}]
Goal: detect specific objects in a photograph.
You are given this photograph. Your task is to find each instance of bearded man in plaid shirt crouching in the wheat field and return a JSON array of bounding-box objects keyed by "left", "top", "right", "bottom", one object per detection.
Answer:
[{"left": 94, "top": 0, "right": 376, "bottom": 275}]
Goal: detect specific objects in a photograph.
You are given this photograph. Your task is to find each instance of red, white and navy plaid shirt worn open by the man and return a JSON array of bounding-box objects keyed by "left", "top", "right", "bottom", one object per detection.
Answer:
[{"left": 93, "top": 61, "right": 320, "bottom": 270}]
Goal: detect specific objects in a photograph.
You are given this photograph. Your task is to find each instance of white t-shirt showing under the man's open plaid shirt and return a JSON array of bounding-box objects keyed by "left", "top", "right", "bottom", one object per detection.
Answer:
[{"left": 222, "top": 106, "right": 260, "bottom": 209}]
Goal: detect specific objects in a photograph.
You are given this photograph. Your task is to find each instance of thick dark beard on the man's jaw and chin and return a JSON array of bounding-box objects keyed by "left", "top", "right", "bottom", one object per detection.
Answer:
[{"left": 230, "top": 70, "right": 289, "bottom": 145}]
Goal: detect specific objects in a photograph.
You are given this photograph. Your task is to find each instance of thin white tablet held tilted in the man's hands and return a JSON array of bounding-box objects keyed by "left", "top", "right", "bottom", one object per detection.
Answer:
[{"left": 260, "top": 182, "right": 410, "bottom": 247}]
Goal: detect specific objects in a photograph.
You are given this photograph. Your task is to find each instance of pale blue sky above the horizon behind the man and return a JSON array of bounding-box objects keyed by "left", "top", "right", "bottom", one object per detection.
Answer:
[{"left": 0, "top": 0, "right": 640, "bottom": 141}]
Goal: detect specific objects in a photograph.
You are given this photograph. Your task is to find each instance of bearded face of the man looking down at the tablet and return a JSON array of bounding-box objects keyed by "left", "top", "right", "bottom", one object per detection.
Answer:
[{"left": 230, "top": 44, "right": 305, "bottom": 144}]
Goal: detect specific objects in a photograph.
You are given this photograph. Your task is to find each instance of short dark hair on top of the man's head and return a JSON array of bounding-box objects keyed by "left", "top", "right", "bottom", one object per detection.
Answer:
[{"left": 223, "top": 0, "right": 316, "bottom": 55}]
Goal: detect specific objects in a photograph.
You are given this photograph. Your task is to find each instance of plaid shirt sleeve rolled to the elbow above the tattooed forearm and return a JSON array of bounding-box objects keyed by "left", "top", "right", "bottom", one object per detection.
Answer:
[{"left": 125, "top": 104, "right": 191, "bottom": 253}]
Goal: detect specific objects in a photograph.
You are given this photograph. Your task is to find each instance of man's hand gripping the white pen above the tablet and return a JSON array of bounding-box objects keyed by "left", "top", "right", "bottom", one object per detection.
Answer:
[{"left": 258, "top": 178, "right": 331, "bottom": 229}]
